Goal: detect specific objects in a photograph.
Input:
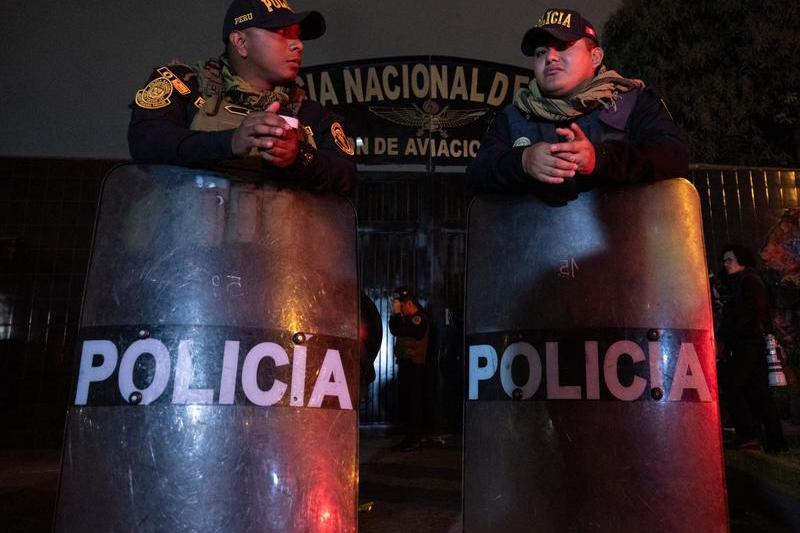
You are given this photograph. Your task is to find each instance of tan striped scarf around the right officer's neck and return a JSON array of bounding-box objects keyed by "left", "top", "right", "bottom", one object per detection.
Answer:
[{"left": 514, "top": 67, "right": 644, "bottom": 122}]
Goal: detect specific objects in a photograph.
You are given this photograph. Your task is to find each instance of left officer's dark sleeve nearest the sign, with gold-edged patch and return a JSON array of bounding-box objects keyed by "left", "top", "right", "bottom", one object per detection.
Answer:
[{"left": 287, "top": 101, "right": 356, "bottom": 197}]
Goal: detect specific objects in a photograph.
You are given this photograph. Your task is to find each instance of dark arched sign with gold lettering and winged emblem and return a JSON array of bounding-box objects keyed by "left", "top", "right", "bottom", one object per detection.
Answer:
[{"left": 299, "top": 56, "right": 531, "bottom": 165}]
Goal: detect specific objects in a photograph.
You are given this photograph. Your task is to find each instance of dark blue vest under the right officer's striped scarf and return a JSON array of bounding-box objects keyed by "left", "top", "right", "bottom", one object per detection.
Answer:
[{"left": 504, "top": 91, "right": 639, "bottom": 146}]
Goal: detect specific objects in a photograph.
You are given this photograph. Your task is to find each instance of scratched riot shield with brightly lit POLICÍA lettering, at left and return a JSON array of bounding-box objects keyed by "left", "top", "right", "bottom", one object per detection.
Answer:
[{"left": 56, "top": 165, "right": 359, "bottom": 532}]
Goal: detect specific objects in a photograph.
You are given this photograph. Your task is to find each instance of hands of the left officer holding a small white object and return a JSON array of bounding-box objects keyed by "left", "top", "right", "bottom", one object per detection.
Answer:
[{"left": 231, "top": 102, "right": 300, "bottom": 168}]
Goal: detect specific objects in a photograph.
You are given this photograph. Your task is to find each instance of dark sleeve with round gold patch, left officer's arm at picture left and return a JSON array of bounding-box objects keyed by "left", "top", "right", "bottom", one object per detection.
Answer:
[{"left": 128, "top": 65, "right": 233, "bottom": 166}]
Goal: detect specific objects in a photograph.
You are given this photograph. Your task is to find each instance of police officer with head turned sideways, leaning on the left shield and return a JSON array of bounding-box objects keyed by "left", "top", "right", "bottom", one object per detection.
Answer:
[{"left": 128, "top": 0, "right": 356, "bottom": 194}]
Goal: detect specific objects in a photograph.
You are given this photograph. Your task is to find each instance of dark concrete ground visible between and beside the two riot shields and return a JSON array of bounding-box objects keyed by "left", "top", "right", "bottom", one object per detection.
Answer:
[{"left": 0, "top": 425, "right": 800, "bottom": 533}]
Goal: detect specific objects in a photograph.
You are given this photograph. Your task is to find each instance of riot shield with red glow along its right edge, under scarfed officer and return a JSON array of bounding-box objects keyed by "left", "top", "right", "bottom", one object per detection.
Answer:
[{"left": 463, "top": 179, "right": 727, "bottom": 533}]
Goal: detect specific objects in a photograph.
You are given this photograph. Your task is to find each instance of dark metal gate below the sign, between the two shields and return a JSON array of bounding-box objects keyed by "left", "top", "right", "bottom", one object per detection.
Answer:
[{"left": 358, "top": 171, "right": 467, "bottom": 432}]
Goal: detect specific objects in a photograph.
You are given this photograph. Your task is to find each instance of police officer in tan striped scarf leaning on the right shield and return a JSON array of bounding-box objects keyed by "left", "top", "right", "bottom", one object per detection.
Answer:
[{"left": 467, "top": 8, "right": 689, "bottom": 192}]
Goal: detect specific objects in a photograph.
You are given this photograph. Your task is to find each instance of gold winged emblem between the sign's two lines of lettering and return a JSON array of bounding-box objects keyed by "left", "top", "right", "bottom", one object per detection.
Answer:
[{"left": 369, "top": 100, "right": 489, "bottom": 139}]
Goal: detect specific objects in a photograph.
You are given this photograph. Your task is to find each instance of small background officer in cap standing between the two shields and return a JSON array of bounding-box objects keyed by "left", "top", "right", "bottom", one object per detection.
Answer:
[{"left": 389, "top": 287, "right": 429, "bottom": 451}]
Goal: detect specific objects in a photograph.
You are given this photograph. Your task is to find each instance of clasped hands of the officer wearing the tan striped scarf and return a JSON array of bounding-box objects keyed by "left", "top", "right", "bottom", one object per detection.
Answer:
[{"left": 522, "top": 123, "right": 595, "bottom": 183}]
